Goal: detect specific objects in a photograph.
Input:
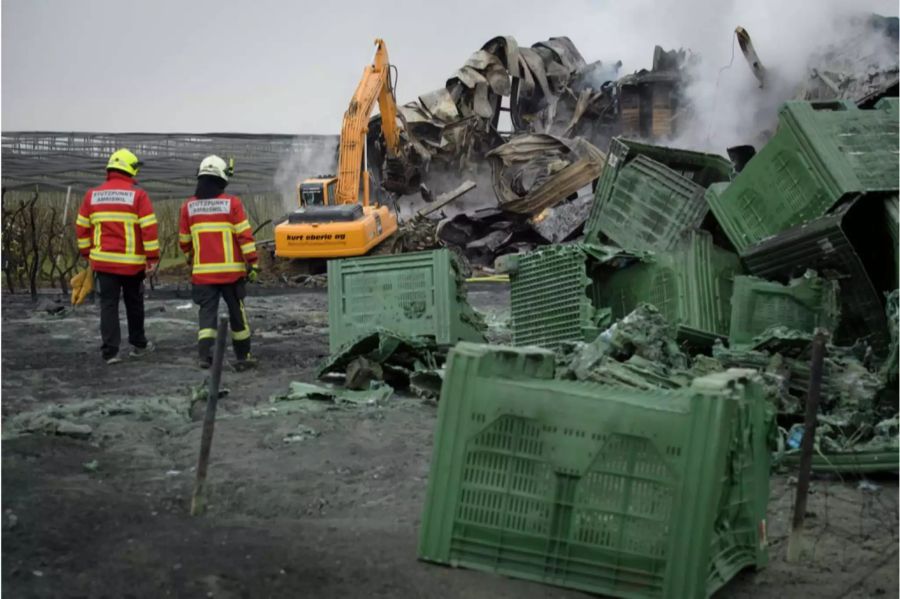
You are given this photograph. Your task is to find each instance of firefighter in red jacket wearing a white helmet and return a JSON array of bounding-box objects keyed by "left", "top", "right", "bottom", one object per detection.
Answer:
[{"left": 178, "top": 156, "right": 259, "bottom": 371}]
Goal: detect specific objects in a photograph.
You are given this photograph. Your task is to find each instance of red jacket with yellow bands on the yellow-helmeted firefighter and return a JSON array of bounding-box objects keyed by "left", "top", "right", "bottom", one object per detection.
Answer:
[{"left": 75, "top": 171, "right": 159, "bottom": 275}]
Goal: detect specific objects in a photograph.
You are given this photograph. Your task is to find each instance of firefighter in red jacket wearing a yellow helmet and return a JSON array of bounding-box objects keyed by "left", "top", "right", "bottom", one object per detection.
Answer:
[{"left": 75, "top": 149, "right": 159, "bottom": 364}]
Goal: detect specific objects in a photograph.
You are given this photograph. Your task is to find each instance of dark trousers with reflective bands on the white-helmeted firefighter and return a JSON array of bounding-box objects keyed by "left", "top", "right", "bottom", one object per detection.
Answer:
[{"left": 191, "top": 279, "right": 250, "bottom": 360}]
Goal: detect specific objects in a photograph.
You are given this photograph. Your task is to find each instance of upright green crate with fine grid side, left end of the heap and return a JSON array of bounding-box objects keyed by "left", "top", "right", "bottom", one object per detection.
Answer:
[{"left": 510, "top": 244, "right": 620, "bottom": 348}]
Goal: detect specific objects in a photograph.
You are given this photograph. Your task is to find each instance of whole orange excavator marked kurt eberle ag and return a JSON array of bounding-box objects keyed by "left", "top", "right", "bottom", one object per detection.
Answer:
[{"left": 275, "top": 39, "right": 414, "bottom": 259}]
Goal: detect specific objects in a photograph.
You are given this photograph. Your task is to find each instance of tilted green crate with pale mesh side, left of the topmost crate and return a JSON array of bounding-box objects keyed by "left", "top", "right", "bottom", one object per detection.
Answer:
[{"left": 585, "top": 138, "right": 731, "bottom": 252}]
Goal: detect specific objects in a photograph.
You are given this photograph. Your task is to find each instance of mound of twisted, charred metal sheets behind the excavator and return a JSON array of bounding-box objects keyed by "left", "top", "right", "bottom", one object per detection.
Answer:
[{"left": 368, "top": 36, "right": 689, "bottom": 269}]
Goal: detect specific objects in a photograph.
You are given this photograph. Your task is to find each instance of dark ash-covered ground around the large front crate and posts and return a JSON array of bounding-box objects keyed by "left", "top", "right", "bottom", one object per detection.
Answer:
[{"left": 2, "top": 285, "right": 898, "bottom": 598}]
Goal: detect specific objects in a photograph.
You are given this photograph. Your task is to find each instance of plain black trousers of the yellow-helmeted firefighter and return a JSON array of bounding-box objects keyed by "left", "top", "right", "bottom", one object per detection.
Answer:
[{"left": 97, "top": 272, "right": 147, "bottom": 360}]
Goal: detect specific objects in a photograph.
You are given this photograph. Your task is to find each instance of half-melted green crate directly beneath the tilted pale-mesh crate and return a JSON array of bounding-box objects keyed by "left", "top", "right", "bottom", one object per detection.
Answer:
[{"left": 595, "top": 231, "right": 742, "bottom": 345}]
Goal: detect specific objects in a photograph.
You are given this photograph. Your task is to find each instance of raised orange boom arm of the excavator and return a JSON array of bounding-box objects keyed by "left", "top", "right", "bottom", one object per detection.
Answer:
[{"left": 335, "top": 39, "right": 400, "bottom": 204}]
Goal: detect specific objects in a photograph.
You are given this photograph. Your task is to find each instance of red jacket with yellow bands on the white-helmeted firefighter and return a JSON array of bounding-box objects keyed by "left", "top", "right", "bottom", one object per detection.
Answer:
[{"left": 178, "top": 193, "right": 257, "bottom": 285}]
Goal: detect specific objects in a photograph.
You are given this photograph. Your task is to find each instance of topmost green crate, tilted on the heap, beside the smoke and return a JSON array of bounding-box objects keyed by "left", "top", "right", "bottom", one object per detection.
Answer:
[{"left": 706, "top": 101, "right": 900, "bottom": 251}]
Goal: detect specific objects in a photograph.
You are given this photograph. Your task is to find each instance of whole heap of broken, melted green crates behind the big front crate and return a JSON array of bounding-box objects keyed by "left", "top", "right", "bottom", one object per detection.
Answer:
[{"left": 498, "top": 98, "right": 898, "bottom": 470}]
